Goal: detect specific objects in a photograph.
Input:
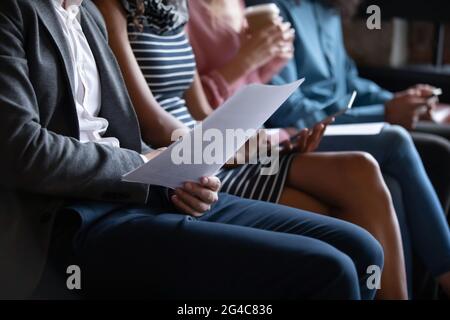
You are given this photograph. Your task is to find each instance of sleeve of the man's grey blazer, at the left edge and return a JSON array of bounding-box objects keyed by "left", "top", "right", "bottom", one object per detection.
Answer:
[{"left": 0, "top": 1, "right": 148, "bottom": 203}]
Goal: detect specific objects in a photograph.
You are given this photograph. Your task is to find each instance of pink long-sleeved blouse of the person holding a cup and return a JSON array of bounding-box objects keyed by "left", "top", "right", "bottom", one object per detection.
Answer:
[{"left": 187, "top": 0, "right": 286, "bottom": 108}]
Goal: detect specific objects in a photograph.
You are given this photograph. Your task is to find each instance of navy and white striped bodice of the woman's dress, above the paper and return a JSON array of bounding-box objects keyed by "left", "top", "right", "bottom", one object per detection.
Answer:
[{"left": 128, "top": 25, "right": 196, "bottom": 128}]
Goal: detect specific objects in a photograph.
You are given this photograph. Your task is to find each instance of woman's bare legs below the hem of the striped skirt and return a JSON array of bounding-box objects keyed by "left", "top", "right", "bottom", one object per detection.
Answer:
[{"left": 280, "top": 152, "right": 407, "bottom": 299}]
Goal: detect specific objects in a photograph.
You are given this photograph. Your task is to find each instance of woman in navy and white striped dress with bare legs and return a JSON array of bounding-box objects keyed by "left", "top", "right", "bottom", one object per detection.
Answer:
[{"left": 96, "top": 0, "right": 406, "bottom": 298}]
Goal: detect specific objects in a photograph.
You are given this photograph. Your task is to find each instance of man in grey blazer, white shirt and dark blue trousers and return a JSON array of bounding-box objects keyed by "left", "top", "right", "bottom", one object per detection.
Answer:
[{"left": 0, "top": 0, "right": 383, "bottom": 299}]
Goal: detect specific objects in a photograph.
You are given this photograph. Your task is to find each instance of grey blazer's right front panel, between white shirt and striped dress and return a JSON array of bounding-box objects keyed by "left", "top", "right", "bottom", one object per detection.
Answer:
[{"left": 81, "top": 3, "right": 142, "bottom": 152}]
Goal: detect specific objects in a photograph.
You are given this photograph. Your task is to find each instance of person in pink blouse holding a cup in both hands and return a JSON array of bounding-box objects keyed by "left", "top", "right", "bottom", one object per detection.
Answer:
[{"left": 188, "top": 0, "right": 294, "bottom": 108}]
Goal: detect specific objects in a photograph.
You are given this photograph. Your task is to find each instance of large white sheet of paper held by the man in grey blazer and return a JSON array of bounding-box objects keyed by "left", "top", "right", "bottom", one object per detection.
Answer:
[{"left": 123, "top": 79, "right": 304, "bottom": 188}]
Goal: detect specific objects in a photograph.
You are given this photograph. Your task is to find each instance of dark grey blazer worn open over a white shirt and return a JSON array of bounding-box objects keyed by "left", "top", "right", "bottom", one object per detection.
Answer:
[{"left": 0, "top": 0, "right": 148, "bottom": 298}]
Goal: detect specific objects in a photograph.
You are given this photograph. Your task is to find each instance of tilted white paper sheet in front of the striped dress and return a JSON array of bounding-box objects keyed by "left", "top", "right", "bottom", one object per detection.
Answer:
[{"left": 123, "top": 79, "right": 304, "bottom": 188}]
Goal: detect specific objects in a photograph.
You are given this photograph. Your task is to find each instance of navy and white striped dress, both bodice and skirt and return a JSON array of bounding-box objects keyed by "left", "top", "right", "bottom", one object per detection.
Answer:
[{"left": 122, "top": 0, "right": 293, "bottom": 203}]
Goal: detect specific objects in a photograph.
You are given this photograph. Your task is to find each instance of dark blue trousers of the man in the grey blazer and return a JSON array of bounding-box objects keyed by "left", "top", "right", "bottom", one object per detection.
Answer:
[{"left": 51, "top": 190, "right": 383, "bottom": 299}]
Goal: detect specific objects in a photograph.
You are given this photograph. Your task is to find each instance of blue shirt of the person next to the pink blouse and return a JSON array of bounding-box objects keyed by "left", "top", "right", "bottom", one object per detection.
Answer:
[{"left": 246, "top": 0, "right": 393, "bottom": 127}]
